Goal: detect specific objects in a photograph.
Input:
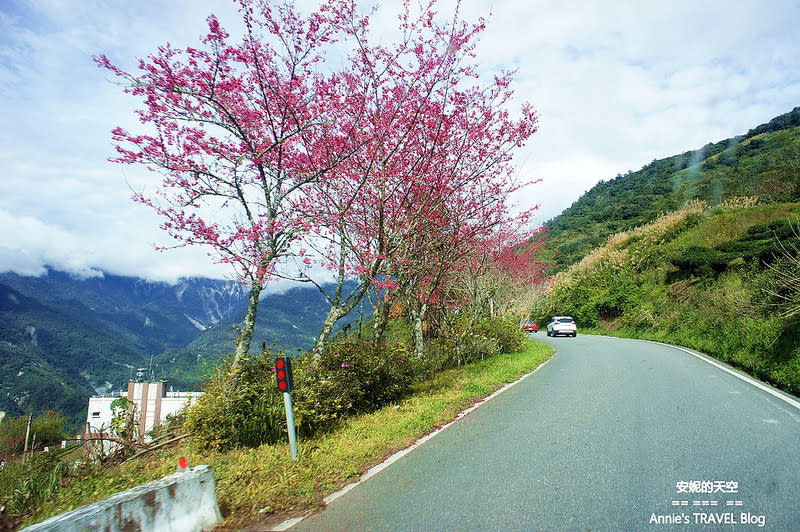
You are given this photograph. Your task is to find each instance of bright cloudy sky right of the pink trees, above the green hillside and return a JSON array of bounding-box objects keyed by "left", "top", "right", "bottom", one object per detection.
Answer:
[{"left": 480, "top": 1, "right": 800, "bottom": 217}]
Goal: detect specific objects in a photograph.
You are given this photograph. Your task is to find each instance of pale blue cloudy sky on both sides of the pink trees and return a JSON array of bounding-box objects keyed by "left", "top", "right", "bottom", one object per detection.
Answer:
[{"left": 0, "top": 0, "right": 800, "bottom": 280}]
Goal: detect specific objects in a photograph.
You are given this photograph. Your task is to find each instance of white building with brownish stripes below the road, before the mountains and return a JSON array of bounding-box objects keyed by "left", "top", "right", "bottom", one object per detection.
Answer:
[{"left": 86, "top": 381, "right": 203, "bottom": 444}]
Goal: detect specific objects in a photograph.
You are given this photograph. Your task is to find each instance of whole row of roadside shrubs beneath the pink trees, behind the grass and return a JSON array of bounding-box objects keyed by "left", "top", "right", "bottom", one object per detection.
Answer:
[{"left": 184, "top": 318, "right": 526, "bottom": 450}]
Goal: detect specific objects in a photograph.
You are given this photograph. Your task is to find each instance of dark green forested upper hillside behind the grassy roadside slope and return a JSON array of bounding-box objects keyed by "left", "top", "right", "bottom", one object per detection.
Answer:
[{"left": 546, "top": 107, "right": 800, "bottom": 269}]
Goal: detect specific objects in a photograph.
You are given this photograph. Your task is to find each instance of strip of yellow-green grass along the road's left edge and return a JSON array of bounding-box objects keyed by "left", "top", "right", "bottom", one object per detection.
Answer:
[{"left": 26, "top": 341, "right": 552, "bottom": 528}]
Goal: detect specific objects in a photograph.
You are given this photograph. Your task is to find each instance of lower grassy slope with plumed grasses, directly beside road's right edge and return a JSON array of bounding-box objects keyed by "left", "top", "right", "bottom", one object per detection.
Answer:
[{"left": 533, "top": 198, "right": 800, "bottom": 394}]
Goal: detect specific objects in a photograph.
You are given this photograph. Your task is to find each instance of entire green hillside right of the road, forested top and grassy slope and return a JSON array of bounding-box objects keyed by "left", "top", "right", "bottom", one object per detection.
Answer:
[{"left": 532, "top": 107, "right": 800, "bottom": 394}]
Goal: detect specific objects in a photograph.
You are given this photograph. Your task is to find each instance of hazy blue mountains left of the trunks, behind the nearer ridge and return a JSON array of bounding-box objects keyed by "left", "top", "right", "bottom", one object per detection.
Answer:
[{"left": 0, "top": 270, "right": 247, "bottom": 424}]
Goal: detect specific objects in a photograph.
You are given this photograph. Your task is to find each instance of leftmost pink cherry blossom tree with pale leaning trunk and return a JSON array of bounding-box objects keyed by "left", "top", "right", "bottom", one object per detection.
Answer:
[{"left": 95, "top": 0, "right": 368, "bottom": 366}]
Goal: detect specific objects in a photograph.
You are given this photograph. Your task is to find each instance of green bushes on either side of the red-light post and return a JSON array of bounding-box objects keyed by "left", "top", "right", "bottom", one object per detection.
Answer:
[{"left": 185, "top": 335, "right": 415, "bottom": 450}]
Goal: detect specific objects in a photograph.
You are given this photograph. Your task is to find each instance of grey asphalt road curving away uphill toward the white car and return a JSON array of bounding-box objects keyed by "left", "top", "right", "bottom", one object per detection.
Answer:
[{"left": 292, "top": 333, "right": 800, "bottom": 531}]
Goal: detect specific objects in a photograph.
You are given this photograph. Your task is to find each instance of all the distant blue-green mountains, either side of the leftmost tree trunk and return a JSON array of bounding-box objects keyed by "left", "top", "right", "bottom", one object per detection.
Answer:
[{"left": 0, "top": 270, "right": 354, "bottom": 427}]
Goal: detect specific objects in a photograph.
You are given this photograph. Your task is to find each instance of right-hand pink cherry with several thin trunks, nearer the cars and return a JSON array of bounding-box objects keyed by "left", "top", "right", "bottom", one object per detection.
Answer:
[{"left": 294, "top": 0, "right": 536, "bottom": 351}]
